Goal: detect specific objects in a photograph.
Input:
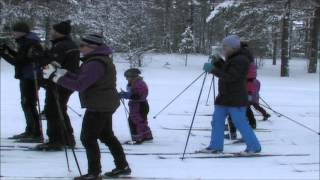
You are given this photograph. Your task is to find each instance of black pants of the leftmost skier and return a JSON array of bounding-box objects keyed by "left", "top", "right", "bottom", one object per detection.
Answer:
[{"left": 20, "top": 79, "right": 41, "bottom": 137}]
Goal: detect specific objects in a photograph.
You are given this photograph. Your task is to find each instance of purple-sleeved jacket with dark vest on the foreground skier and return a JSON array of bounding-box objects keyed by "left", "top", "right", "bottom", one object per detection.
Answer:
[{"left": 58, "top": 45, "right": 120, "bottom": 112}]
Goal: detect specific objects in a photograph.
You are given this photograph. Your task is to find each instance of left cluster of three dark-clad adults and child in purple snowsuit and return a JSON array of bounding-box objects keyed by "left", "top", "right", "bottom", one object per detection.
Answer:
[{"left": 0, "top": 21, "right": 153, "bottom": 180}]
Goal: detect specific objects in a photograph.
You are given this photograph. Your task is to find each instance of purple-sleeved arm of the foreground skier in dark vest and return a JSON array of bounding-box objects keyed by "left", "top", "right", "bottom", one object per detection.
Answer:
[{"left": 56, "top": 61, "right": 105, "bottom": 92}]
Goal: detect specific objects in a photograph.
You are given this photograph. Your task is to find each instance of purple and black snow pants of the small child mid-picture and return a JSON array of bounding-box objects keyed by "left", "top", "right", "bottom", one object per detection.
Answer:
[{"left": 129, "top": 101, "right": 153, "bottom": 141}]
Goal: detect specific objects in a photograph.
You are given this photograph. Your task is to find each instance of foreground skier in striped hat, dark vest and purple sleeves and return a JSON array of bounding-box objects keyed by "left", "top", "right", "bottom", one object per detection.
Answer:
[{"left": 43, "top": 34, "right": 131, "bottom": 180}]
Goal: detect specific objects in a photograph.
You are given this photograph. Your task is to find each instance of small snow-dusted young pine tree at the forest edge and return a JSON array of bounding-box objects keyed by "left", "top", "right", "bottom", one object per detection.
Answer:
[{"left": 179, "top": 26, "right": 194, "bottom": 66}]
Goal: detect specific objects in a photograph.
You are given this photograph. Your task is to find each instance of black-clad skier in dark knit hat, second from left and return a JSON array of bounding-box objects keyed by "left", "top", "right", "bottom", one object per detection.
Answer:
[{"left": 35, "top": 21, "right": 80, "bottom": 151}]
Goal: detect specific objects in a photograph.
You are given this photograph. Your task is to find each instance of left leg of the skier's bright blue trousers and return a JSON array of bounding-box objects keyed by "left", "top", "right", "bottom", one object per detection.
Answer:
[{"left": 208, "top": 105, "right": 228, "bottom": 151}]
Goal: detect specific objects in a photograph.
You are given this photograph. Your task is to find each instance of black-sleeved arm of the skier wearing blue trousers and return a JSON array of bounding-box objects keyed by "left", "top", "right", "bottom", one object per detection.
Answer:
[{"left": 212, "top": 56, "right": 248, "bottom": 82}]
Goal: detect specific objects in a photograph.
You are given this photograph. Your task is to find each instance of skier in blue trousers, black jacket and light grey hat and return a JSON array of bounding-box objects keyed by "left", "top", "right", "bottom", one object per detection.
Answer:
[{"left": 201, "top": 35, "right": 261, "bottom": 154}]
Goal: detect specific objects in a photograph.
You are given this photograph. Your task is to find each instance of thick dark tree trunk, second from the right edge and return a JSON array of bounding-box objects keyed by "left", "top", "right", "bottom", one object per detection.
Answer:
[{"left": 280, "top": 0, "right": 291, "bottom": 77}]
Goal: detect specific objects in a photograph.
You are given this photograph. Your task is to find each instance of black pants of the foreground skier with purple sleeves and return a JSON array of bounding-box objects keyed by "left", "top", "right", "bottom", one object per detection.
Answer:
[{"left": 81, "top": 110, "right": 128, "bottom": 174}]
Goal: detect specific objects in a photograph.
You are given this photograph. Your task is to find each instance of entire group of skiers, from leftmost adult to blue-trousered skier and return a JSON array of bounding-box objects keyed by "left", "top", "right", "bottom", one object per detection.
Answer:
[{"left": 0, "top": 21, "right": 270, "bottom": 180}]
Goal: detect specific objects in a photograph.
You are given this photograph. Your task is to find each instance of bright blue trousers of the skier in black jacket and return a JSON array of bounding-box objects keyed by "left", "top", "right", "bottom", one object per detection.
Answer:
[{"left": 208, "top": 105, "right": 261, "bottom": 151}]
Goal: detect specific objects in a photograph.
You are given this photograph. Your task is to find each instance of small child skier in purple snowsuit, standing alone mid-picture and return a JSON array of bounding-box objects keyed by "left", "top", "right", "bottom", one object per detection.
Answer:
[{"left": 119, "top": 68, "right": 153, "bottom": 144}]
